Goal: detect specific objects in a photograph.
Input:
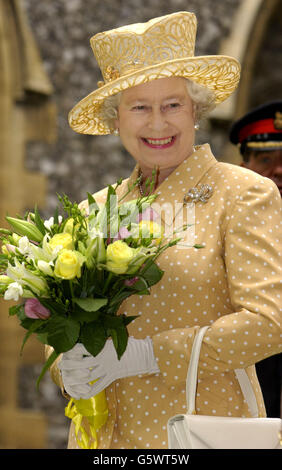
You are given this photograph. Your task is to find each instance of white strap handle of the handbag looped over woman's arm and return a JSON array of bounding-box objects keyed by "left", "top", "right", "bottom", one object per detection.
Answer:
[{"left": 186, "top": 326, "right": 258, "bottom": 418}]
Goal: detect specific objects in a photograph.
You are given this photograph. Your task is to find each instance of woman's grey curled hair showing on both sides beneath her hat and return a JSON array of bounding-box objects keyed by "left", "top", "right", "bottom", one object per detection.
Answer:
[{"left": 100, "top": 79, "right": 216, "bottom": 131}]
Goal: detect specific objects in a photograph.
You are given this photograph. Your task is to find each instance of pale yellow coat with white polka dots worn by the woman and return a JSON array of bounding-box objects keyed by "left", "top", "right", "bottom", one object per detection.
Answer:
[{"left": 47, "top": 144, "right": 282, "bottom": 449}]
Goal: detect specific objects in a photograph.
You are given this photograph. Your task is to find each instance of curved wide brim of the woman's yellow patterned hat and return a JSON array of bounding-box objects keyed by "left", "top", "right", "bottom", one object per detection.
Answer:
[{"left": 69, "top": 55, "right": 241, "bottom": 135}]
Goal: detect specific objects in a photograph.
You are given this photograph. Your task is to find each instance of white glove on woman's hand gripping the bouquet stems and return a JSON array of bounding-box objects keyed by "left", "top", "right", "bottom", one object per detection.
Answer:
[{"left": 59, "top": 337, "right": 160, "bottom": 399}]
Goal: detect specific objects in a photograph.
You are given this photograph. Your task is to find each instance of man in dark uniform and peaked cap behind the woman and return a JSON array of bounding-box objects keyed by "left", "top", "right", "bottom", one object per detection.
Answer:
[{"left": 230, "top": 100, "right": 282, "bottom": 418}]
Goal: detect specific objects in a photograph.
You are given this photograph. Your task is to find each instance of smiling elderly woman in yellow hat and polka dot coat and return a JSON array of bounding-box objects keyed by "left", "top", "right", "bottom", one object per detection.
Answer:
[{"left": 49, "top": 12, "right": 282, "bottom": 449}]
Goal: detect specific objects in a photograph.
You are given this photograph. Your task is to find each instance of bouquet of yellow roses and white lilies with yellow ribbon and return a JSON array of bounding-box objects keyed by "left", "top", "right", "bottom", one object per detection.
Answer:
[{"left": 0, "top": 176, "right": 202, "bottom": 448}]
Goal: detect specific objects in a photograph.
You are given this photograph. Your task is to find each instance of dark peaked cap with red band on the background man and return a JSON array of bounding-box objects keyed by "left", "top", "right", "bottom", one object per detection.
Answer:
[{"left": 229, "top": 100, "right": 282, "bottom": 155}]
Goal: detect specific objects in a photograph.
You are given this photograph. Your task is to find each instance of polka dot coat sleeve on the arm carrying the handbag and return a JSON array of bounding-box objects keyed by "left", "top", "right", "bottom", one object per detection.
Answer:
[{"left": 153, "top": 178, "right": 282, "bottom": 385}]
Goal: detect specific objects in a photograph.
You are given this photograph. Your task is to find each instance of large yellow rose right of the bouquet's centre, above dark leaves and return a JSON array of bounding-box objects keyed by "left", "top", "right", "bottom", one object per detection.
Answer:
[{"left": 106, "top": 240, "right": 136, "bottom": 274}]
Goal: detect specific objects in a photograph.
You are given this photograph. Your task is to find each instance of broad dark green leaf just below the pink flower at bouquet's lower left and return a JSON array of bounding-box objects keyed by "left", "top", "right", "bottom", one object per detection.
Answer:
[{"left": 45, "top": 315, "right": 80, "bottom": 353}]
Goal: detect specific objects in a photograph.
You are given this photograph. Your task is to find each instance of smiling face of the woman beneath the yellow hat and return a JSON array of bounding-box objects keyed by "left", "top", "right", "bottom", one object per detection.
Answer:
[{"left": 116, "top": 77, "right": 195, "bottom": 173}]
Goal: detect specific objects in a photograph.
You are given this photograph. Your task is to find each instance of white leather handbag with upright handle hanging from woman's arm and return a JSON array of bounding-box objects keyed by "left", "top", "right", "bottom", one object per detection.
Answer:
[{"left": 167, "top": 326, "right": 282, "bottom": 449}]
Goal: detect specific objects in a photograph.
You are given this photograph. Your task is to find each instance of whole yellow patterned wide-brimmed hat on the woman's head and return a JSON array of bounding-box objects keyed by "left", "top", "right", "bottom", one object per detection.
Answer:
[{"left": 69, "top": 11, "right": 240, "bottom": 135}]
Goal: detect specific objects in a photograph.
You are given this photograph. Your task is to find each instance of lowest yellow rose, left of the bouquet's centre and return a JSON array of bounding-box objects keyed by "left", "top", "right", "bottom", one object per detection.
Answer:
[{"left": 54, "top": 250, "right": 84, "bottom": 279}]
